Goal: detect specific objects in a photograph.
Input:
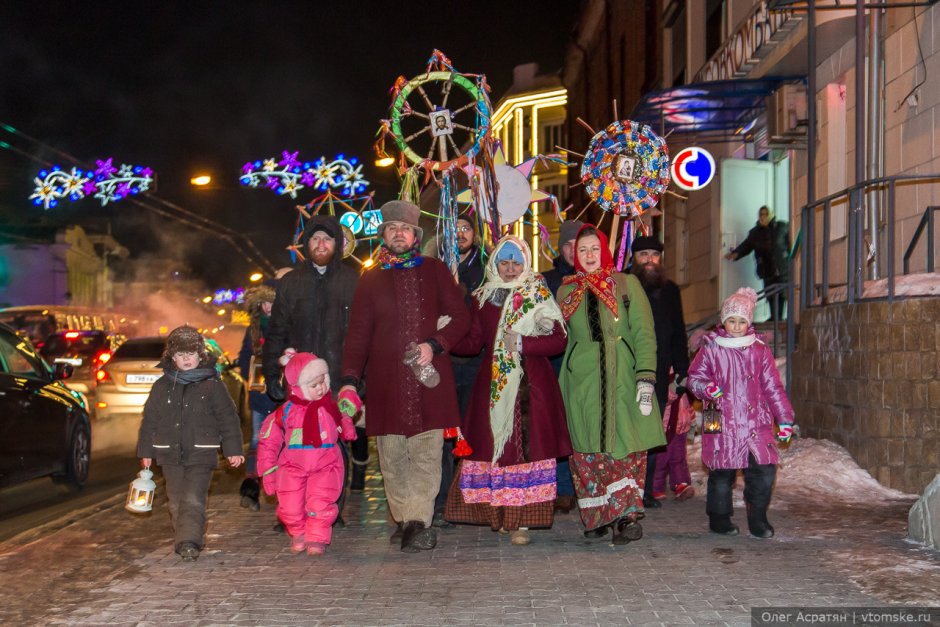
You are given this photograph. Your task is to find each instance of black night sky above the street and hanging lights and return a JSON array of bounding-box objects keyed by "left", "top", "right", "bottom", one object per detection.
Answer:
[{"left": 0, "top": 0, "right": 579, "bottom": 287}]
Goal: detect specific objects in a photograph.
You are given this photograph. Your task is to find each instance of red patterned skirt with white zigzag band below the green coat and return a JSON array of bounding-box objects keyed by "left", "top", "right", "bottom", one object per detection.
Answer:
[{"left": 571, "top": 451, "right": 646, "bottom": 530}]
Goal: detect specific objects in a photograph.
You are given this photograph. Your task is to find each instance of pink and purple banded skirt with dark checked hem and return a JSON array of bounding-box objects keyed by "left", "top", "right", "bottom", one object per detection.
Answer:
[{"left": 444, "top": 459, "right": 557, "bottom": 531}]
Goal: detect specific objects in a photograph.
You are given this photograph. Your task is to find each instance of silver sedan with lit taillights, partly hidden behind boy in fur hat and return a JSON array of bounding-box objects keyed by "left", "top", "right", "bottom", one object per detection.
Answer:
[{"left": 95, "top": 337, "right": 251, "bottom": 433}]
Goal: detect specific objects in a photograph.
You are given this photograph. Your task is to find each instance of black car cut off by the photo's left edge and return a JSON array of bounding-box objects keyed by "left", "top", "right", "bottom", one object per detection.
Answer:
[{"left": 0, "top": 324, "right": 91, "bottom": 487}]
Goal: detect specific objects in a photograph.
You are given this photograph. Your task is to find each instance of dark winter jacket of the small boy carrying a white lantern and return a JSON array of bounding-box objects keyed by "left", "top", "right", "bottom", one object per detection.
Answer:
[{"left": 137, "top": 360, "right": 243, "bottom": 467}]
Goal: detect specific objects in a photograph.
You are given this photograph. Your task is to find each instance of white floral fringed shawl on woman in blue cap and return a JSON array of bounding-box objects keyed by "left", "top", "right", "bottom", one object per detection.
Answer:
[{"left": 473, "top": 235, "right": 565, "bottom": 464}]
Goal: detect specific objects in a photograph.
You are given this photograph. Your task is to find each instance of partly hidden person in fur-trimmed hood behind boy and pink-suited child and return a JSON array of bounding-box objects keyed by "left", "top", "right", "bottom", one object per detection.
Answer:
[{"left": 238, "top": 283, "right": 277, "bottom": 512}]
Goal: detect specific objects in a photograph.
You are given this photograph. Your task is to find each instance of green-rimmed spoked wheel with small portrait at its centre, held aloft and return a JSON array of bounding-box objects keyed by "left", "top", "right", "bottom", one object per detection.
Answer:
[{"left": 391, "top": 71, "right": 490, "bottom": 170}]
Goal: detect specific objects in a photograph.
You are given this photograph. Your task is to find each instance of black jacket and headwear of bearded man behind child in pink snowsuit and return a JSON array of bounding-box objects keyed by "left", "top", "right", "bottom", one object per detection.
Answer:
[{"left": 262, "top": 215, "right": 359, "bottom": 393}]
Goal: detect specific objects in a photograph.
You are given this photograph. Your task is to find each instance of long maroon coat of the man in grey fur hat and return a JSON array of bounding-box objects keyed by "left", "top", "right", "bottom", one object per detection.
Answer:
[{"left": 342, "top": 257, "right": 470, "bottom": 437}]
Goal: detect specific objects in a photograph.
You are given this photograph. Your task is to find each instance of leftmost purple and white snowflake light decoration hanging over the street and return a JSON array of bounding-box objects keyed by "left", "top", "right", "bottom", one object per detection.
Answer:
[{"left": 29, "top": 158, "right": 153, "bottom": 209}]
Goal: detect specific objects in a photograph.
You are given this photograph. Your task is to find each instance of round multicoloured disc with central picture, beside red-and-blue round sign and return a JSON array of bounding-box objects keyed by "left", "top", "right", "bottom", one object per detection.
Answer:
[{"left": 581, "top": 120, "right": 670, "bottom": 218}]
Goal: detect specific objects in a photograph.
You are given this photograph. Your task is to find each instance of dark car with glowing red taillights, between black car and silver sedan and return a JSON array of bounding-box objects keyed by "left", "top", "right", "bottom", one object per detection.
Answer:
[{"left": 39, "top": 330, "right": 124, "bottom": 400}]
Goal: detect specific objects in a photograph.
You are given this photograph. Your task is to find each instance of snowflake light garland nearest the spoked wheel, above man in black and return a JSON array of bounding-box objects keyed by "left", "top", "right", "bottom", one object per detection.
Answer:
[{"left": 238, "top": 150, "right": 369, "bottom": 198}]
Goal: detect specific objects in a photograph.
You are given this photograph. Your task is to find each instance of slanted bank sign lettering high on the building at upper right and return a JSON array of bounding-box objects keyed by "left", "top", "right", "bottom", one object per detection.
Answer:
[{"left": 694, "top": 0, "right": 794, "bottom": 83}]
